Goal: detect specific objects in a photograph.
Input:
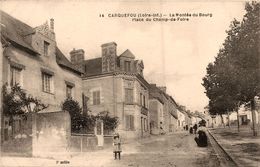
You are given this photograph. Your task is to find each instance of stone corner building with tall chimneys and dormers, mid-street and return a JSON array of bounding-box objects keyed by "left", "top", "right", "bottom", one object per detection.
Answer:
[{"left": 70, "top": 42, "right": 149, "bottom": 139}]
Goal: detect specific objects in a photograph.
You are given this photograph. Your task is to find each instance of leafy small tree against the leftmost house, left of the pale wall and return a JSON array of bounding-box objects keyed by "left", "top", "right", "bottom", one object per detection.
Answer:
[{"left": 2, "top": 84, "right": 48, "bottom": 135}]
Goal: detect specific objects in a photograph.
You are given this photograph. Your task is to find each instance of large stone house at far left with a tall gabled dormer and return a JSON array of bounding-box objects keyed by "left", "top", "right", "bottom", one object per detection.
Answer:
[{"left": 0, "top": 11, "right": 82, "bottom": 154}]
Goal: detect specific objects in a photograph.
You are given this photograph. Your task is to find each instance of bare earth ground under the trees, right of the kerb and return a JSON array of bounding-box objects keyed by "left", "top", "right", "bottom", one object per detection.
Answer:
[{"left": 210, "top": 126, "right": 260, "bottom": 167}]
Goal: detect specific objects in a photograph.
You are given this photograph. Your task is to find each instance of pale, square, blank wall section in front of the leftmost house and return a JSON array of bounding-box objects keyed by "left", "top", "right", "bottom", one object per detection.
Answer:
[{"left": 32, "top": 111, "right": 71, "bottom": 157}]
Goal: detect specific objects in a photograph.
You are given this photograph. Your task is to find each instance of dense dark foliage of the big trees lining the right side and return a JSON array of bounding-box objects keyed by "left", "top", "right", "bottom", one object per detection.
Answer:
[{"left": 202, "top": 1, "right": 260, "bottom": 115}]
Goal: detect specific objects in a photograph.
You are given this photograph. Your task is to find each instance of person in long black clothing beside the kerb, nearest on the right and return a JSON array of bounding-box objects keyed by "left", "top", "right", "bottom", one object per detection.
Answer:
[{"left": 194, "top": 120, "right": 208, "bottom": 147}]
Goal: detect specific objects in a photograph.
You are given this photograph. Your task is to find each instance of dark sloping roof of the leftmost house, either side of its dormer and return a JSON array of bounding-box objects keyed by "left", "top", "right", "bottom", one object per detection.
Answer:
[{"left": 0, "top": 10, "right": 83, "bottom": 74}]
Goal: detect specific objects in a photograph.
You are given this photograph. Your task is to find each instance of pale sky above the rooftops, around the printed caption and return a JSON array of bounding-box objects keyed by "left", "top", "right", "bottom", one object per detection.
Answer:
[{"left": 0, "top": 0, "right": 245, "bottom": 112}]
